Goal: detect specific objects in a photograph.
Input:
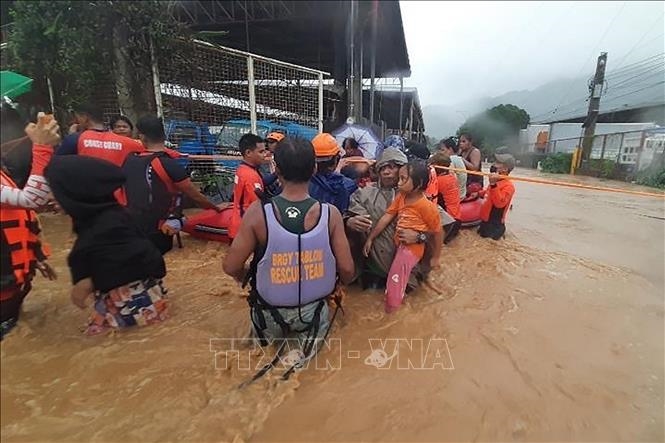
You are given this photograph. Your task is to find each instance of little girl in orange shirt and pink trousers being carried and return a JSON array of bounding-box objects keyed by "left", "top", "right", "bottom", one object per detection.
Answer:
[{"left": 363, "top": 160, "right": 443, "bottom": 313}]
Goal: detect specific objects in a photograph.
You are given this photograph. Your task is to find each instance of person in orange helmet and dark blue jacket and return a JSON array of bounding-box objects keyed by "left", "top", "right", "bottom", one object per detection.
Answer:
[{"left": 309, "top": 132, "right": 358, "bottom": 213}]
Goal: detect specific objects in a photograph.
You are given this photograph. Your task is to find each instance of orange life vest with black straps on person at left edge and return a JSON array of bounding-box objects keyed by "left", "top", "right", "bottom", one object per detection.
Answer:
[{"left": 0, "top": 171, "right": 46, "bottom": 289}]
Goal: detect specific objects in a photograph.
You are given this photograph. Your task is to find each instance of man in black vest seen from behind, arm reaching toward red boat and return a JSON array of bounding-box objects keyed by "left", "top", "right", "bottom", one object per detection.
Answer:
[{"left": 122, "top": 116, "right": 221, "bottom": 254}]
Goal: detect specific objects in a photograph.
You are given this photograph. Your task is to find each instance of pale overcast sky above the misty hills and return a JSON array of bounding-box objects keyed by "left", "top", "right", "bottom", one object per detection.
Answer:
[{"left": 400, "top": 1, "right": 665, "bottom": 106}]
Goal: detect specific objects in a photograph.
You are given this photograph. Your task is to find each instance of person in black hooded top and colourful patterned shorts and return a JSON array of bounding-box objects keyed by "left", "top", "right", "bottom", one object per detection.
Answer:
[{"left": 46, "top": 155, "right": 167, "bottom": 335}]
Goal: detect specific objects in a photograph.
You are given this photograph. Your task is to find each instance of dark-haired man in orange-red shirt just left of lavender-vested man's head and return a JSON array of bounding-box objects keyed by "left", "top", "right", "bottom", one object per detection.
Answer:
[{"left": 229, "top": 134, "right": 270, "bottom": 239}]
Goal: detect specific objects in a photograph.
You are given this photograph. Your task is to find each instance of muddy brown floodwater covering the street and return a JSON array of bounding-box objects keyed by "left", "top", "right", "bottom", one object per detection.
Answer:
[{"left": 1, "top": 170, "right": 665, "bottom": 442}]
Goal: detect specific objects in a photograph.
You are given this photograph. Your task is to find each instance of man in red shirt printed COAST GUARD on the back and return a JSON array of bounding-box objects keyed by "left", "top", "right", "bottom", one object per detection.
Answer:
[{"left": 55, "top": 105, "right": 145, "bottom": 166}]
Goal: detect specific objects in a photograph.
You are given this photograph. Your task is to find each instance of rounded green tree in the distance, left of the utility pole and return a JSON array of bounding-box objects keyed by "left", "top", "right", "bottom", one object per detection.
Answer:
[{"left": 457, "top": 104, "right": 531, "bottom": 157}]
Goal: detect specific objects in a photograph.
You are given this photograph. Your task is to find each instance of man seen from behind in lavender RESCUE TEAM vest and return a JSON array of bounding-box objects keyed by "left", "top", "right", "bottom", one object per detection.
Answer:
[{"left": 223, "top": 138, "right": 354, "bottom": 370}]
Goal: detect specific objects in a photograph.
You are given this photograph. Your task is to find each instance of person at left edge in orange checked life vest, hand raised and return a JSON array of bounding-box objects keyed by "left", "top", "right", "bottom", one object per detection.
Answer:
[{"left": 0, "top": 108, "right": 60, "bottom": 340}]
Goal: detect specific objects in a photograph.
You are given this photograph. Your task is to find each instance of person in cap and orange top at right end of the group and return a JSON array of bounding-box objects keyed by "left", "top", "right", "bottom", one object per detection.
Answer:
[{"left": 478, "top": 153, "right": 515, "bottom": 240}]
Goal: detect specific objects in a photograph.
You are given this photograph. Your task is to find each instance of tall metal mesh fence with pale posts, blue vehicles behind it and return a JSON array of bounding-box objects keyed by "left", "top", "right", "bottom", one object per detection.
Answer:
[{"left": 154, "top": 41, "right": 328, "bottom": 184}]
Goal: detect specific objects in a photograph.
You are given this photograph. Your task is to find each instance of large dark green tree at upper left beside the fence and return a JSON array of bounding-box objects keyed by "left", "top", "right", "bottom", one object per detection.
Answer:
[{"left": 9, "top": 0, "right": 186, "bottom": 123}]
